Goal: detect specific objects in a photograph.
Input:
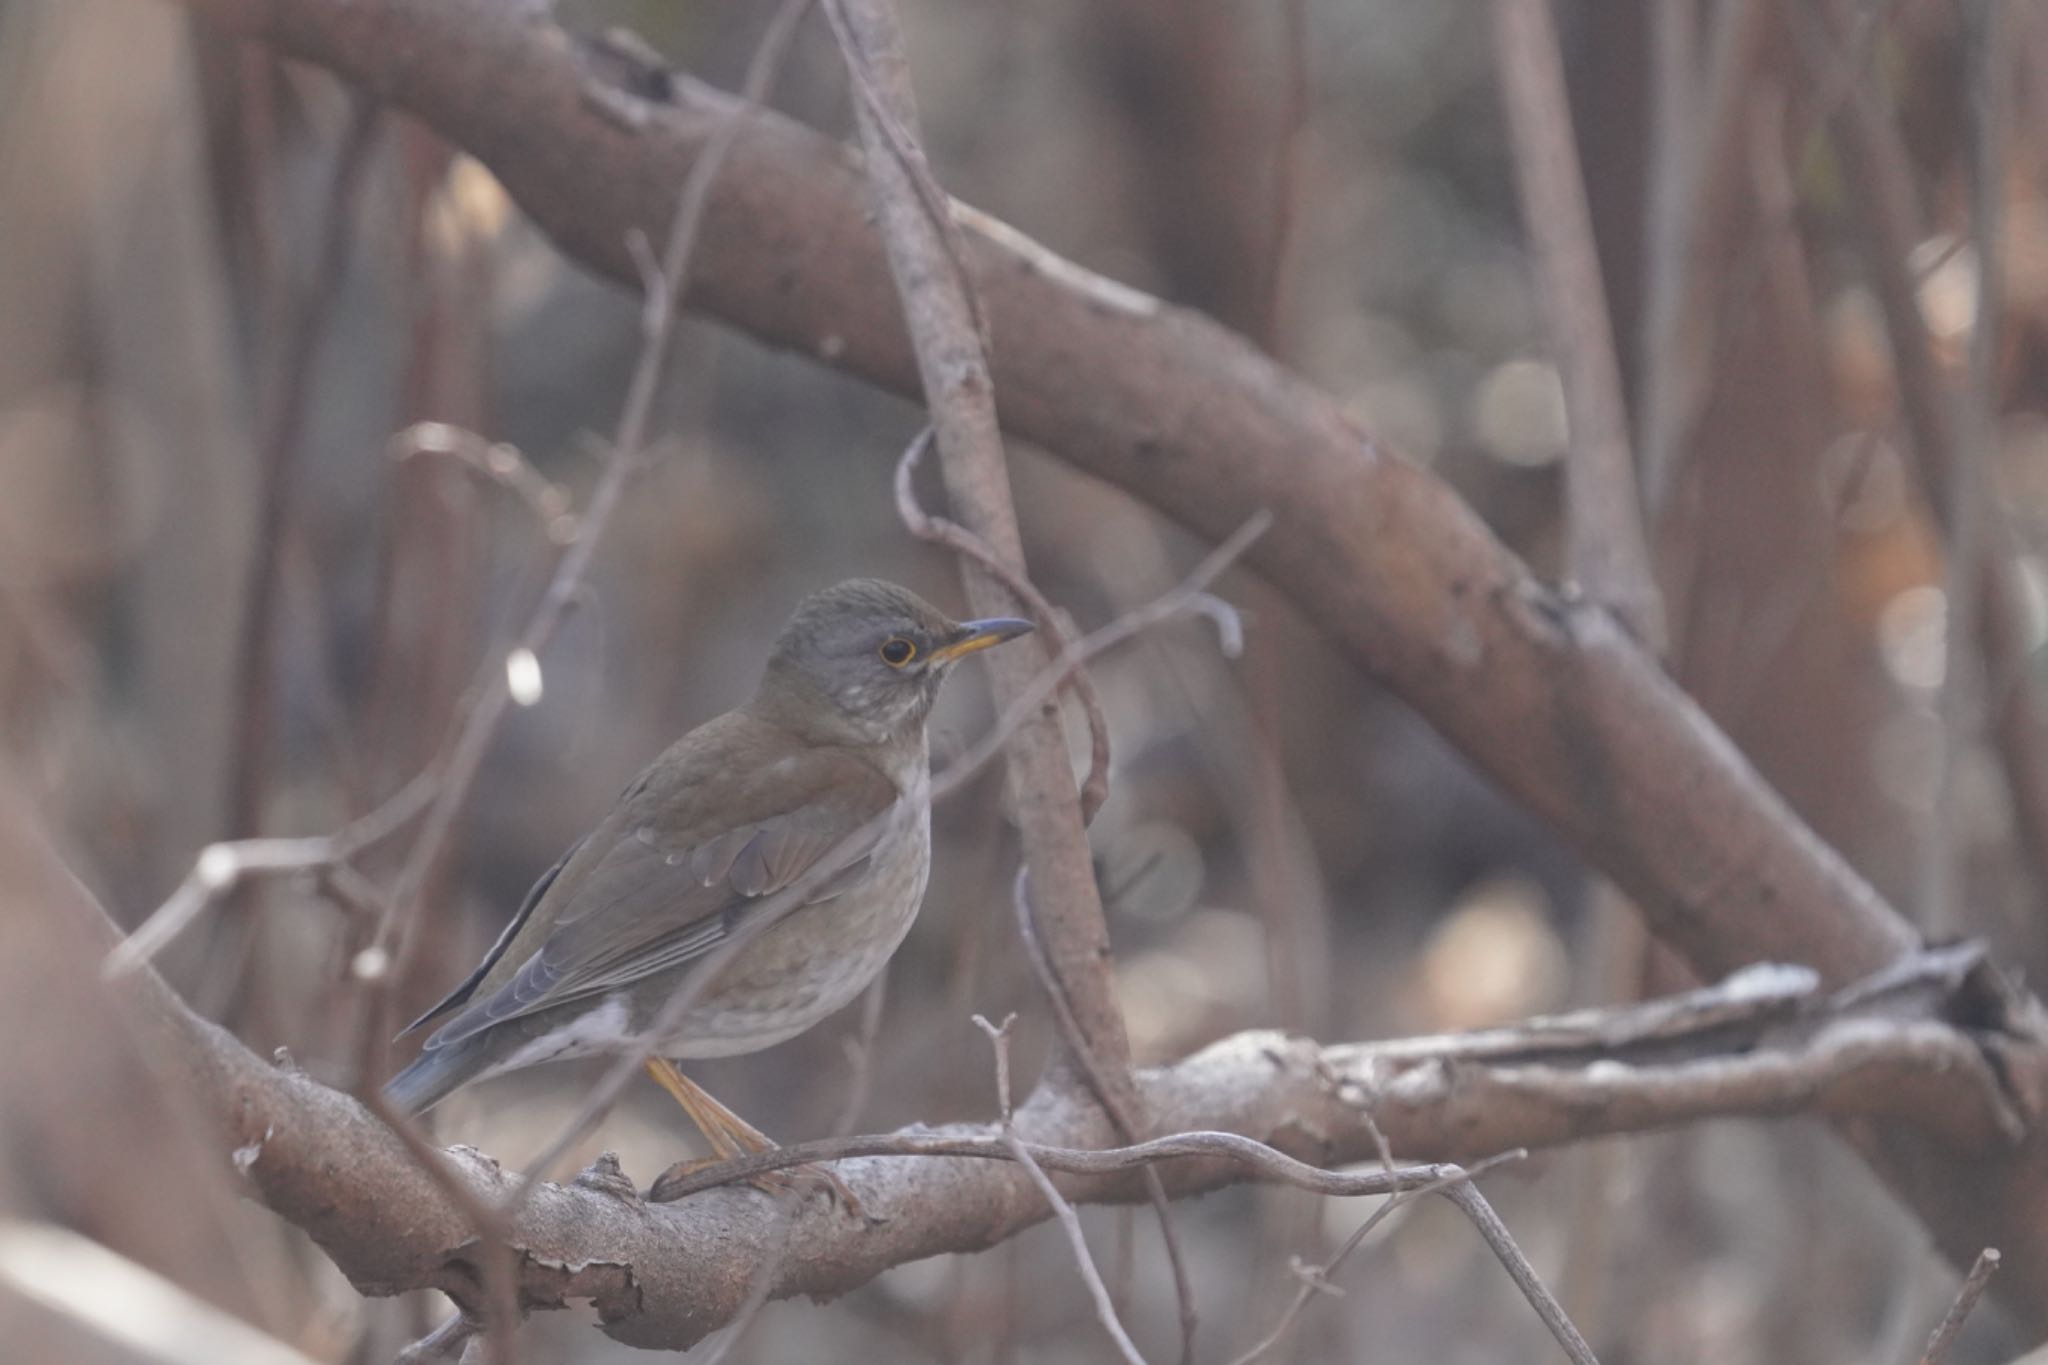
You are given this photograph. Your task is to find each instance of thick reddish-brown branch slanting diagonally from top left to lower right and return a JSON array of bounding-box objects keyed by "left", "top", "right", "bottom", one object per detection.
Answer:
[{"left": 155, "top": 0, "right": 2048, "bottom": 1330}]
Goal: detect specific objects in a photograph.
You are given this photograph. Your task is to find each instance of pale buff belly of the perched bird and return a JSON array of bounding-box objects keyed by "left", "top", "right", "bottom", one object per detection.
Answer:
[{"left": 649, "top": 808, "right": 932, "bottom": 1058}]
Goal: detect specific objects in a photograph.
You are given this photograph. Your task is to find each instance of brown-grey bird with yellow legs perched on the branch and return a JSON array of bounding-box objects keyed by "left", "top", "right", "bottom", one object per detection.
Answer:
[{"left": 383, "top": 579, "right": 1032, "bottom": 1207}]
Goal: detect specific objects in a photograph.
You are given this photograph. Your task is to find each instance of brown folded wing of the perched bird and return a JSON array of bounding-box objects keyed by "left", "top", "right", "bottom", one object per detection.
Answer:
[{"left": 426, "top": 763, "right": 899, "bottom": 1048}]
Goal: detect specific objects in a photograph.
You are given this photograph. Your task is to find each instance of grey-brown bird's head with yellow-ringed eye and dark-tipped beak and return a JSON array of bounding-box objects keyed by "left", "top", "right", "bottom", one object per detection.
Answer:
[{"left": 756, "top": 579, "right": 1032, "bottom": 743}]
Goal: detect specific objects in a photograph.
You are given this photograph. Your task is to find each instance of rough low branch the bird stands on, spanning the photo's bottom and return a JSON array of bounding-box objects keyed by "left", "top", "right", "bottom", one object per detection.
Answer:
[{"left": 119, "top": 859, "right": 2021, "bottom": 1349}]
